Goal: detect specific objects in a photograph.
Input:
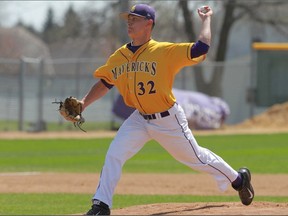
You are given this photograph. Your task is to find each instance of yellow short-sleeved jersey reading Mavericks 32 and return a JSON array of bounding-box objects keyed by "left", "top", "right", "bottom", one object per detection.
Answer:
[{"left": 94, "top": 40, "right": 206, "bottom": 114}]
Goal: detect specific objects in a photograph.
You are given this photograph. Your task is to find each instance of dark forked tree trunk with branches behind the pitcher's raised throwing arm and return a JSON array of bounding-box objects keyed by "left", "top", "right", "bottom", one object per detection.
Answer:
[{"left": 179, "top": 0, "right": 288, "bottom": 97}]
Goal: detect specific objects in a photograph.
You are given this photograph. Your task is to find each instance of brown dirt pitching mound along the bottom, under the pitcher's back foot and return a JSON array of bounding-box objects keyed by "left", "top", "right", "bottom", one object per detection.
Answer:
[{"left": 112, "top": 202, "right": 288, "bottom": 215}]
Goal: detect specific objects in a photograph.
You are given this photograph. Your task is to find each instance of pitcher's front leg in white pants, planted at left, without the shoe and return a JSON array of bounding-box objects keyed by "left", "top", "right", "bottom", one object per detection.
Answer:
[{"left": 93, "top": 114, "right": 150, "bottom": 208}]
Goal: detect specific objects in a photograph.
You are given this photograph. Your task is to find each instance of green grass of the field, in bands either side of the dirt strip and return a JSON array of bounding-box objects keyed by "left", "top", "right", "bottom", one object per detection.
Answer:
[{"left": 0, "top": 134, "right": 288, "bottom": 215}]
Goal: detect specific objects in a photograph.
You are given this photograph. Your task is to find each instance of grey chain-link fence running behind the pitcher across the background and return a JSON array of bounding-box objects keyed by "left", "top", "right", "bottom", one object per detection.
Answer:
[{"left": 0, "top": 58, "right": 251, "bottom": 131}]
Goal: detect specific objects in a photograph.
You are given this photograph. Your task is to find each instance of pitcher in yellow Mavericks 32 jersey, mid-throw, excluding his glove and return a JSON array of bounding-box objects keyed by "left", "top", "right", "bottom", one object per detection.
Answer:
[{"left": 81, "top": 4, "right": 254, "bottom": 215}]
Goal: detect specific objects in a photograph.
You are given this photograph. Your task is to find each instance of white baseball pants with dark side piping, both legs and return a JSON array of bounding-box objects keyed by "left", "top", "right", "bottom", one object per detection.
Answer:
[{"left": 93, "top": 103, "right": 238, "bottom": 208}]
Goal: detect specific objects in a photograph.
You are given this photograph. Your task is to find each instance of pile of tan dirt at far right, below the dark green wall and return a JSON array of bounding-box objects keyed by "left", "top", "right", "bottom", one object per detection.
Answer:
[{"left": 233, "top": 102, "right": 288, "bottom": 129}]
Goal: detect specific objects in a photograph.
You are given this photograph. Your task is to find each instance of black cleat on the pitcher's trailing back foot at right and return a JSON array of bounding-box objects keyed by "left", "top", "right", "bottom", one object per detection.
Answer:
[{"left": 235, "top": 168, "right": 254, "bottom": 205}]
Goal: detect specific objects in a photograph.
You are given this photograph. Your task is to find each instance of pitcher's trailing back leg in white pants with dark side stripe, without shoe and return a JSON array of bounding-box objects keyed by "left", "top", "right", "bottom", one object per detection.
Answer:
[{"left": 150, "top": 106, "right": 238, "bottom": 190}]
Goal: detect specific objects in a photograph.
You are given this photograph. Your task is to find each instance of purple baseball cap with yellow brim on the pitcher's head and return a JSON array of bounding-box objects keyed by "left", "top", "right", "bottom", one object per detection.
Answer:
[{"left": 120, "top": 4, "right": 155, "bottom": 23}]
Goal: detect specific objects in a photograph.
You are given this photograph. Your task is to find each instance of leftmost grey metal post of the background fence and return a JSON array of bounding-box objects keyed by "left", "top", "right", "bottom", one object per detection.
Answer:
[{"left": 18, "top": 58, "right": 26, "bottom": 131}]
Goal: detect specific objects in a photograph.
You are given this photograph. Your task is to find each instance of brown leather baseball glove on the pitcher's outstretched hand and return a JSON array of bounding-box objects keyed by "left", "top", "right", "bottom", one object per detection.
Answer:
[{"left": 53, "top": 96, "right": 86, "bottom": 132}]
